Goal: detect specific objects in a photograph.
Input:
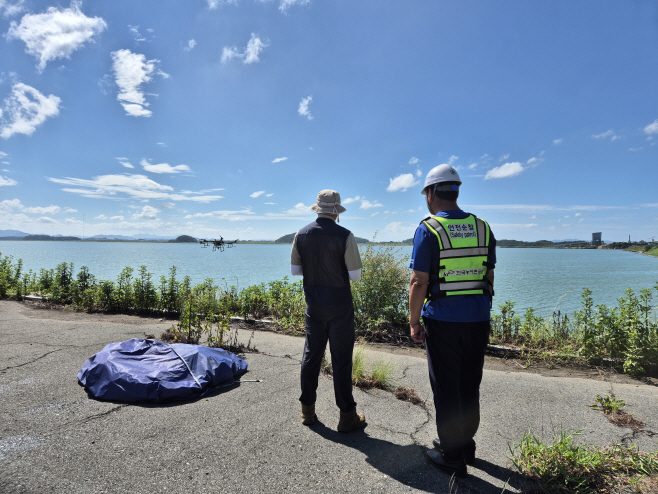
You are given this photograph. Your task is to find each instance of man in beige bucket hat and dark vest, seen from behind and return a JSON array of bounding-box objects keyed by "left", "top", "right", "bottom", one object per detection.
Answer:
[{"left": 290, "top": 190, "right": 366, "bottom": 432}]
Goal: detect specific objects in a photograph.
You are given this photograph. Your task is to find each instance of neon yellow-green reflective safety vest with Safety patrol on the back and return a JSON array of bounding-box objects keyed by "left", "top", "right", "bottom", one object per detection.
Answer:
[{"left": 423, "top": 215, "right": 489, "bottom": 299}]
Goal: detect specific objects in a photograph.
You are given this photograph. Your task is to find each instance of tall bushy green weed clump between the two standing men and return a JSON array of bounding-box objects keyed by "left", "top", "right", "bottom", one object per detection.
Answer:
[{"left": 352, "top": 245, "right": 410, "bottom": 337}]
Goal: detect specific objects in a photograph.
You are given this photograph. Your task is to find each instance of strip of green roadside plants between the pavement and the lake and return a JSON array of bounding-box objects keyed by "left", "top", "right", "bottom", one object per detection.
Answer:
[{"left": 0, "top": 249, "right": 658, "bottom": 377}]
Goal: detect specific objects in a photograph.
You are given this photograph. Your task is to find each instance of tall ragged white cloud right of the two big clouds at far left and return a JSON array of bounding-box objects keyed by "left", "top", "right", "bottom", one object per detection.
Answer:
[{"left": 112, "top": 50, "right": 169, "bottom": 117}]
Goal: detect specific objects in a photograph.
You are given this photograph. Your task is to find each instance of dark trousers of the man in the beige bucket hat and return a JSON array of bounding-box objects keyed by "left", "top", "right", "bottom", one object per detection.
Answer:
[{"left": 299, "top": 304, "right": 356, "bottom": 412}]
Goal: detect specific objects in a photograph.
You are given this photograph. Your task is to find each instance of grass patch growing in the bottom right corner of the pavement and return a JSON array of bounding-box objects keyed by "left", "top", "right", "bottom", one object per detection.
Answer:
[{"left": 509, "top": 431, "right": 658, "bottom": 494}]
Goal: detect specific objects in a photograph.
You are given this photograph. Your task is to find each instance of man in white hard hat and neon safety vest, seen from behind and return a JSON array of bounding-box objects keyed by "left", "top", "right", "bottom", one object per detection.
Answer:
[{"left": 409, "top": 165, "right": 496, "bottom": 477}]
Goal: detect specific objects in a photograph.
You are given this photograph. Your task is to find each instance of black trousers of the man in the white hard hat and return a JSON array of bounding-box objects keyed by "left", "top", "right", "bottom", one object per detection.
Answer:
[{"left": 423, "top": 318, "right": 490, "bottom": 459}]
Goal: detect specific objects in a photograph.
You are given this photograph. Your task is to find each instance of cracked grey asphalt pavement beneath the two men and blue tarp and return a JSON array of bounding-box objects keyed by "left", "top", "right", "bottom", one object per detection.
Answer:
[{"left": 0, "top": 301, "right": 658, "bottom": 494}]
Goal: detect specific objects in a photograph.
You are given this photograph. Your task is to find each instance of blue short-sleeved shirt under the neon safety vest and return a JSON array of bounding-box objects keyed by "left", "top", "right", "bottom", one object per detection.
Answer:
[{"left": 409, "top": 209, "right": 496, "bottom": 322}]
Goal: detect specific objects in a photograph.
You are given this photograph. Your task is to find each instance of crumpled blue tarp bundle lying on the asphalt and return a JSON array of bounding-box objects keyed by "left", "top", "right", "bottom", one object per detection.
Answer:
[{"left": 78, "top": 338, "right": 247, "bottom": 403}]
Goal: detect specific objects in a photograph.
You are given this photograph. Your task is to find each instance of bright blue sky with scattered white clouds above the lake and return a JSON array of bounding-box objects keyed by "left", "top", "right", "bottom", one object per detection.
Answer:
[{"left": 0, "top": 0, "right": 658, "bottom": 241}]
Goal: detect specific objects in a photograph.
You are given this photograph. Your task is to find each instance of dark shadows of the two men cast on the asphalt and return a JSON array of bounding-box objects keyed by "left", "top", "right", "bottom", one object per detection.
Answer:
[{"left": 309, "top": 421, "right": 519, "bottom": 494}]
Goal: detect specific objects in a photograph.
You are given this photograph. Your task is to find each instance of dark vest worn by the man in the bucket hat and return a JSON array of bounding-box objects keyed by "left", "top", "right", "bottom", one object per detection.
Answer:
[{"left": 297, "top": 217, "right": 352, "bottom": 306}]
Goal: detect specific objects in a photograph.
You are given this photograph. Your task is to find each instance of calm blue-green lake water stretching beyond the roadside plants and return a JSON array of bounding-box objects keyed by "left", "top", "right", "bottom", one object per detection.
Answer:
[{"left": 0, "top": 241, "right": 658, "bottom": 317}]
